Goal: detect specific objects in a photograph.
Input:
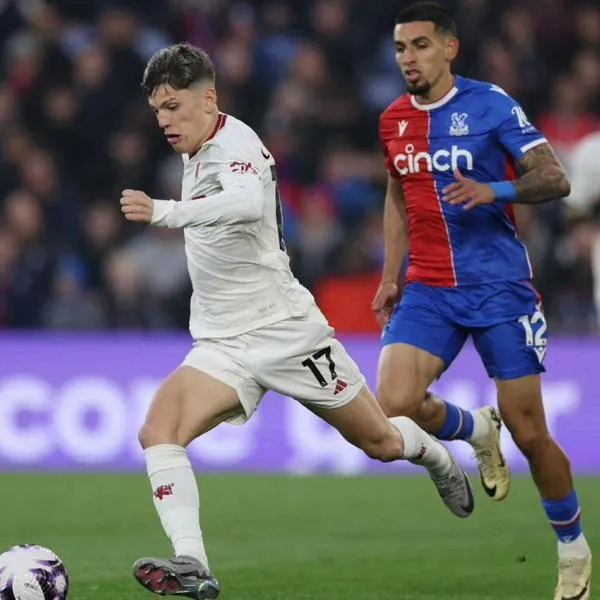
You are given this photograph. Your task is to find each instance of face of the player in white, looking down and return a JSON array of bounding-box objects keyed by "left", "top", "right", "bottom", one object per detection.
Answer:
[{"left": 149, "top": 84, "right": 218, "bottom": 154}]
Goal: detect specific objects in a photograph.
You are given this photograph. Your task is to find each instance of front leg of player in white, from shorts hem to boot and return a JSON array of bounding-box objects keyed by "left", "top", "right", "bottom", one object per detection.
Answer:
[{"left": 136, "top": 367, "right": 240, "bottom": 598}]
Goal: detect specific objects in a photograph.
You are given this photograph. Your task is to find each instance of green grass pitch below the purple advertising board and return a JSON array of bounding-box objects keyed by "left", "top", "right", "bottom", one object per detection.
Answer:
[{"left": 0, "top": 474, "right": 600, "bottom": 600}]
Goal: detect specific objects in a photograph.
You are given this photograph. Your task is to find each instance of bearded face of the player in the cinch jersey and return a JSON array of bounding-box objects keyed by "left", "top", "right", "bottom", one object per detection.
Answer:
[{"left": 394, "top": 21, "right": 458, "bottom": 97}]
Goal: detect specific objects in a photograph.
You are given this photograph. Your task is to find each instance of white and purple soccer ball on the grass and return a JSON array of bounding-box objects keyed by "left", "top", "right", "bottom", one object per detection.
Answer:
[{"left": 0, "top": 544, "right": 69, "bottom": 600}]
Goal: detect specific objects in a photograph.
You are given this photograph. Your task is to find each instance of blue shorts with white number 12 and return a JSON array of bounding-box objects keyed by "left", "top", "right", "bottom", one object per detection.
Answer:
[{"left": 382, "top": 282, "right": 548, "bottom": 379}]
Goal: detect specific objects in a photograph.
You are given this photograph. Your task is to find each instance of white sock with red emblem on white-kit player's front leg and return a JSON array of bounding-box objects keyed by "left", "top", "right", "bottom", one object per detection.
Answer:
[{"left": 144, "top": 444, "right": 208, "bottom": 568}]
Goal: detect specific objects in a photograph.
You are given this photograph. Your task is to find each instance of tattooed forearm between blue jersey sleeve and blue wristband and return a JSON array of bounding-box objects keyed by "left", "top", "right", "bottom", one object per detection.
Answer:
[{"left": 514, "top": 143, "right": 571, "bottom": 204}]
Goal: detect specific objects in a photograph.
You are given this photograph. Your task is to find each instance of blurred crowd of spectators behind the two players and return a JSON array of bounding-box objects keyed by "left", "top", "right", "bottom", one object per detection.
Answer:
[{"left": 0, "top": 0, "right": 600, "bottom": 333}]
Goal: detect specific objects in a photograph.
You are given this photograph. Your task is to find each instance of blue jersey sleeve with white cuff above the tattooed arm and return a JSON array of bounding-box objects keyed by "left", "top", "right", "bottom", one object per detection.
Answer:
[{"left": 488, "top": 86, "right": 547, "bottom": 160}]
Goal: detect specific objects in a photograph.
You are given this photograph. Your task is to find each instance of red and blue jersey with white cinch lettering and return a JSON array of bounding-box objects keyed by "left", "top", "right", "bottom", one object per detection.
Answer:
[{"left": 379, "top": 77, "right": 546, "bottom": 287}]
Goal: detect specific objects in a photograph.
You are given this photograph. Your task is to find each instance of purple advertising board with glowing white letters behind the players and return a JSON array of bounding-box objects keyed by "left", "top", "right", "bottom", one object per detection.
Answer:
[{"left": 0, "top": 334, "right": 600, "bottom": 474}]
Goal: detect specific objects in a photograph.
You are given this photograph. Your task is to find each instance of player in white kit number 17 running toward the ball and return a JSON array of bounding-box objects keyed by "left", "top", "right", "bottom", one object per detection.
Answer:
[{"left": 121, "top": 44, "right": 474, "bottom": 599}]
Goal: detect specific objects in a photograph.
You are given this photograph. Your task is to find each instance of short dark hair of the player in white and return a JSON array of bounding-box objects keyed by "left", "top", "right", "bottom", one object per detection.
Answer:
[{"left": 142, "top": 43, "right": 216, "bottom": 97}]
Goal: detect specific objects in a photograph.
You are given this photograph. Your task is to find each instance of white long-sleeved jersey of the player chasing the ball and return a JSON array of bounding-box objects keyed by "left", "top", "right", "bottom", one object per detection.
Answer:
[{"left": 152, "top": 114, "right": 314, "bottom": 340}]
